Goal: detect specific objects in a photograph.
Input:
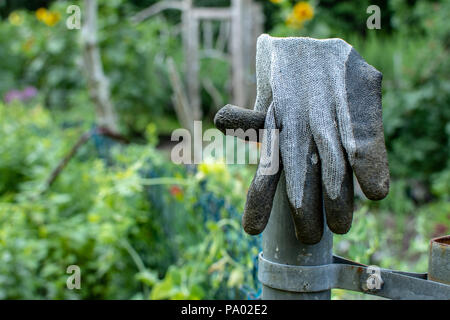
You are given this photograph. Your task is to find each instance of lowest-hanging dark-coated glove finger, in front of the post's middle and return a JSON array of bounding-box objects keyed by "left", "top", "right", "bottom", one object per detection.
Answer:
[{"left": 289, "top": 139, "right": 323, "bottom": 244}]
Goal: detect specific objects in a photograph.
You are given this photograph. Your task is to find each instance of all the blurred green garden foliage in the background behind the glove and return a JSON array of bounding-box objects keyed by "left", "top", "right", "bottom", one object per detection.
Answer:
[{"left": 0, "top": 0, "right": 450, "bottom": 299}]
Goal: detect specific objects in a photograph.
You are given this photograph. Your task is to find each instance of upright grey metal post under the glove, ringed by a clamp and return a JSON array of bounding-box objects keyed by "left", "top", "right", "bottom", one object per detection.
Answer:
[{"left": 262, "top": 173, "right": 333, "bottom": 300}]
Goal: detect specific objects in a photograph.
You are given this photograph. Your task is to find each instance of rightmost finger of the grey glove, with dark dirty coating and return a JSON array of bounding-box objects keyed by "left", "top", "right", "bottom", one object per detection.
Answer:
[{"left": 337, "top": 49, "right": 389, "bottom": 200}]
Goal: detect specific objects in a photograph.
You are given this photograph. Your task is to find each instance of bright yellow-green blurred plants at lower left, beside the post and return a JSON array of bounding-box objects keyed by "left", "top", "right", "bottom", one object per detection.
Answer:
[{"left": 0, "top": 103, "right": 258, "bottom": 299}]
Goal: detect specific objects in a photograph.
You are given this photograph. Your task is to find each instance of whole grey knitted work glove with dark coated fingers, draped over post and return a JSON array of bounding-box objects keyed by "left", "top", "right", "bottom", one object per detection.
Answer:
[{"left": 215, "top": 34, "right": 389, "bottom": 244}]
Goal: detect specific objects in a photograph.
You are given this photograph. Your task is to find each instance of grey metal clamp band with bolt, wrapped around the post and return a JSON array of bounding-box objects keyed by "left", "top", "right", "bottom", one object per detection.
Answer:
[{"left": 258, "top": 252, "right": 450, "bottom": 300}]
